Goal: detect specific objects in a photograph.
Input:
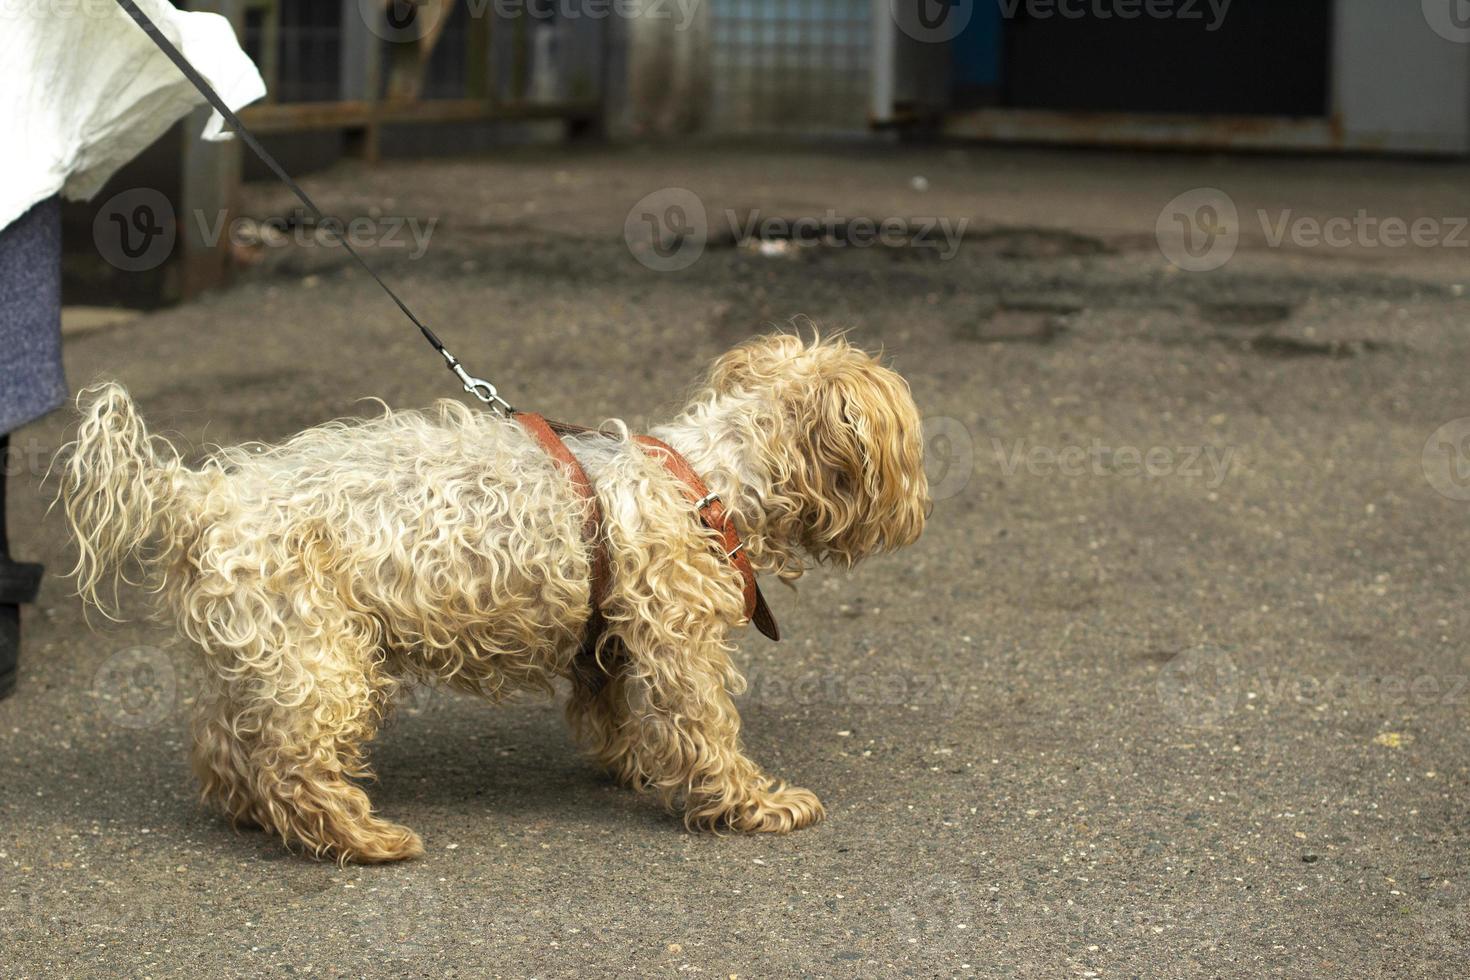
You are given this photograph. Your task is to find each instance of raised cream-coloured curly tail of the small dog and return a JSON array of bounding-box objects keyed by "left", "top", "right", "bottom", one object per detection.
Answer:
[{"left": 53, "top": 382, "right": 196, "bottom": 619}]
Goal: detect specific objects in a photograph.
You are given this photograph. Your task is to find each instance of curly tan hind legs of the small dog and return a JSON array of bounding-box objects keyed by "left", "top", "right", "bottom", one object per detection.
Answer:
[{"left": 194, "top": 620, "right": 423, "bottom": 864}]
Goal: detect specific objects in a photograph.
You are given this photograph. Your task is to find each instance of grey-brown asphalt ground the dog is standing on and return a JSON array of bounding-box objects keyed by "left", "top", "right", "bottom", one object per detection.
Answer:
[{"left": 0, "top": 145, "right": 1470, "bottom": 977}]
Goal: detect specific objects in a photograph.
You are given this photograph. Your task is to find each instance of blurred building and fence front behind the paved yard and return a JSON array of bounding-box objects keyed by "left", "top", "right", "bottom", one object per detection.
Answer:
[{"left": 69, "top": 0, "right": 1470, "bottom": 304}]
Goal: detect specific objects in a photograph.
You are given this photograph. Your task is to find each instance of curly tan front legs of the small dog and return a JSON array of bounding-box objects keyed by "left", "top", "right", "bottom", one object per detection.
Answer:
[{"left": 567, "top": 638, "right": 823, "bottom": 833}]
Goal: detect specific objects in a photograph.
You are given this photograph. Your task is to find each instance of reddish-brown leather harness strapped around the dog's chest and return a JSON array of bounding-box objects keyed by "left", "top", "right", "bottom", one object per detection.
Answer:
[{"left": 512, "top": 411, "right": 781, "bottom": 689}]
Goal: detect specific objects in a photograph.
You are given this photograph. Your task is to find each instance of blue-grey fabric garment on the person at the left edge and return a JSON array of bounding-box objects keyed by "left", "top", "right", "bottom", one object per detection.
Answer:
[{"left": 0, "top": 197, "right": 66, "bottom": 433}]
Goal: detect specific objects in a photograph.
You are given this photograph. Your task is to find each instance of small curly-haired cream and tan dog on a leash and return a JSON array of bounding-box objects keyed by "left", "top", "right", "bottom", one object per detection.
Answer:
[{"left": 60, "top": 334, "right": 928, "bottom": 861}]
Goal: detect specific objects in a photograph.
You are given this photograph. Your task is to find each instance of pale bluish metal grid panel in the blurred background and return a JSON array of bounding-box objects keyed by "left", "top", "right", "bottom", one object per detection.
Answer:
[{"left": 710, "top": 0, "right": 872, "bottom": 132}]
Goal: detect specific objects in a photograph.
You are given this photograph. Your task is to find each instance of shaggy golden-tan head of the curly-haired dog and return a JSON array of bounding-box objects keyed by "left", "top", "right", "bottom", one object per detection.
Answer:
[{"left": 710, "top": 334, "right": 929, "bottom": 575}]
